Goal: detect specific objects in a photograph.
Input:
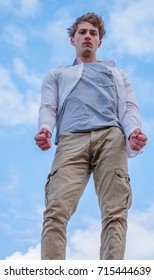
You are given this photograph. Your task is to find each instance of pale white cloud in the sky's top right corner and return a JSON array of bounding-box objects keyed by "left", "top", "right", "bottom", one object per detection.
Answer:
[{"left": 109, "top": 0, "right": 154, "bottom": 56}]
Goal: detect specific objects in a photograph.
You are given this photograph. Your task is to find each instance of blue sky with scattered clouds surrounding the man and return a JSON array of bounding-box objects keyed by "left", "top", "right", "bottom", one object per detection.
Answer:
[{"left": 0, "top": 0, "right": 154, "bottom": 260}]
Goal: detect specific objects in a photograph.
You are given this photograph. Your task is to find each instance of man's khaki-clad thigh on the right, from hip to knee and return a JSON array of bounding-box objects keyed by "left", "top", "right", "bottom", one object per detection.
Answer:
[{"left": 93, "top": 127, "right": 132, "bottom": 216}]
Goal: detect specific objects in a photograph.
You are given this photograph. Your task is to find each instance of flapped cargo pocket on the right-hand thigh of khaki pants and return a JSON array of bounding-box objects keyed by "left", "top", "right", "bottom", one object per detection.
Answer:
[{"left": 114, "top": 169, "right": 132, "bottom": 208}]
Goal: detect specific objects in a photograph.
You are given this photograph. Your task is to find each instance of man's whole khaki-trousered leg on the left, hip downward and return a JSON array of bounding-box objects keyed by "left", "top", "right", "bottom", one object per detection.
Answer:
[{"left": 41, "top": 133, "right": 90, "bottom": 260}]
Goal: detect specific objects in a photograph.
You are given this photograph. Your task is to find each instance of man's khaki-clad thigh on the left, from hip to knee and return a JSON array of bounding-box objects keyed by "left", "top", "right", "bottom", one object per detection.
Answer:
[{"left": 45, "top": 133, "right": 90, "bottom": 214}]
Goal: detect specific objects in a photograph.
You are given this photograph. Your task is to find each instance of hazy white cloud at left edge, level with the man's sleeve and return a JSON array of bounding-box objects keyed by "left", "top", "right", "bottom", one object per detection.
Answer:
[{"left": 0, "top": 60, "right": 42, "bottom": 125}]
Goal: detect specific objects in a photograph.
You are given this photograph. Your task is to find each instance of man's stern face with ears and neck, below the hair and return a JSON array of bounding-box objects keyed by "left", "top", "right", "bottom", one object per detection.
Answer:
[{"left": 71, "top": 22, "right": 101, "bottom": 61}]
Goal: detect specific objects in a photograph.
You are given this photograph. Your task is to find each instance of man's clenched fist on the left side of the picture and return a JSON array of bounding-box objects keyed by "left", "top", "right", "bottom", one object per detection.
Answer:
[{"left": 34, "top": 128, "right": 51, "bottom": 151}]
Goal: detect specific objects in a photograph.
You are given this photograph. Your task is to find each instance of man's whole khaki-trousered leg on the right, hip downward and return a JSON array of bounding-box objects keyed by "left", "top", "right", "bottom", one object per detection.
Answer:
[{"left": 93, "top": 127, "right": 132, "bottom": 260}]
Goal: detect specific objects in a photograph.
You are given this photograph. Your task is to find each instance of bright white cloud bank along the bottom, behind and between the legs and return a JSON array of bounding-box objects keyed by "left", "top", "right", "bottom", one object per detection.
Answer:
[{"left": 7, "top": 205, "right": 154, "bottom": 260}]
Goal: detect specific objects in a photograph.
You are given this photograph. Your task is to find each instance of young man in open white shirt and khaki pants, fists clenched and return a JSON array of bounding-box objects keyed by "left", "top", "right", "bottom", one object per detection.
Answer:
[{"left": 35, "top": 13, "right": 147, "bottom": 260}]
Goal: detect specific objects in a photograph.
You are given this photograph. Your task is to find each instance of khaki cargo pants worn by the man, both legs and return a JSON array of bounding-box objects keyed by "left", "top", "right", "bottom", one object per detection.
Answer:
[{"left": 41, "top": 127, "right": 132, "bottom": 260}]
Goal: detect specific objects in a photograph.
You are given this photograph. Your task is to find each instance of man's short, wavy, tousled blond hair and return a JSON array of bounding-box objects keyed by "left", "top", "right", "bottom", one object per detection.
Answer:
[{"left": 67, "top": 12, "right": 106, "bottom": 39}]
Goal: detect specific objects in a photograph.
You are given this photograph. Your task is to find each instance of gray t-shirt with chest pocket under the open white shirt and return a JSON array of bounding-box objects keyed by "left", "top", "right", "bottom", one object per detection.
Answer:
[{"left": 55, "top": 62, "right": 120, "bottom": 143}]
